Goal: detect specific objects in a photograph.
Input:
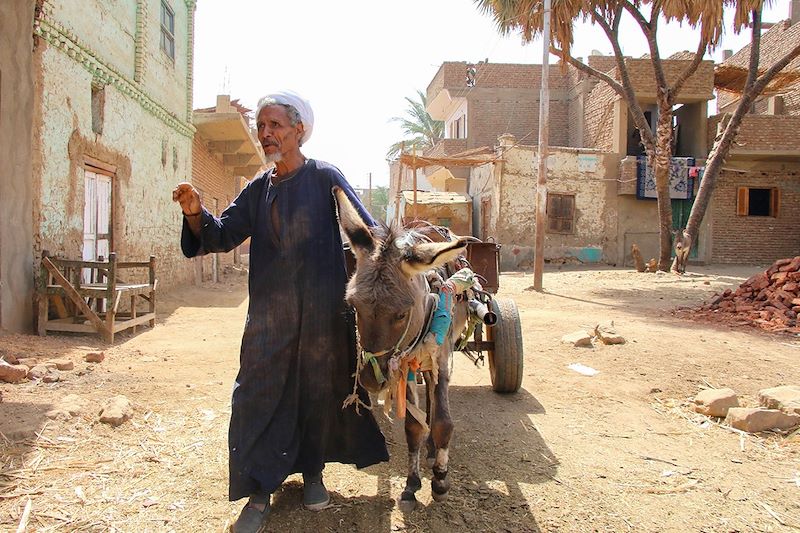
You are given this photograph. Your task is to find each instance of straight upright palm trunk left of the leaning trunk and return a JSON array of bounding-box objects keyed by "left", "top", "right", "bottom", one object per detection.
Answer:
[{"left": 648, "top": 101, "right": 673, "bottom": 271}]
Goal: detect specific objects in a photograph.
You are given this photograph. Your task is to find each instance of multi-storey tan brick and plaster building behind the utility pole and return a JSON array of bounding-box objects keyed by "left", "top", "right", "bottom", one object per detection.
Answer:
[{"left": 425, "top": 56, "right": 714, "bottom": 268}]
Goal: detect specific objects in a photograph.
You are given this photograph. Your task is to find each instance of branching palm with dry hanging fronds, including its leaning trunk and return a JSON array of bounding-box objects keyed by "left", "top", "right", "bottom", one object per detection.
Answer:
[{"left": 475, "top": 0, "right": 800, "bottom": 270}]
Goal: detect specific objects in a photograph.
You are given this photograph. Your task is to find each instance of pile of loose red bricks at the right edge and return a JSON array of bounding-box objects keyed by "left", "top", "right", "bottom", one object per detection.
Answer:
[{"left": 700, "top": 256, "right": 800, "bottom": 333}]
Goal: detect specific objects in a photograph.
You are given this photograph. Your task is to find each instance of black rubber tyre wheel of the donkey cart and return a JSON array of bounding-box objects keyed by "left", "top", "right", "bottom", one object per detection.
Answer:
[{"left": 486, "top": 298, "right": 524, "bottom": 392}]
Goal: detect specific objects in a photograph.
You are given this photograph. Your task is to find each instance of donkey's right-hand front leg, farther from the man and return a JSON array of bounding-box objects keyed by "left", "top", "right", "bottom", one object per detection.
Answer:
[{"left": 431, "top": 356, "right": 453, "bottom": 502}]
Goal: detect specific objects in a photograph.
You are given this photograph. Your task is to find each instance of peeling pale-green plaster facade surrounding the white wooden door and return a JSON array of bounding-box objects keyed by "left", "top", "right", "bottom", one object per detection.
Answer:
[{"left": 33, "top": 0, "right": 194, "bottom": 300}]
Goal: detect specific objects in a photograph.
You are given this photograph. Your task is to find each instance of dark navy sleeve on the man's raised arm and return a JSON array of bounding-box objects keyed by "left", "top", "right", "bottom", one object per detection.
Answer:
[{"left": 181, "top": 178, "right": 263, "bottom": 257}]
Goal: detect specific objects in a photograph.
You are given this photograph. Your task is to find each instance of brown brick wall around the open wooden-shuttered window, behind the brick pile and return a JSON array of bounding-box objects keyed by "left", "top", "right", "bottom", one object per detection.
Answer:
[{"left": 711, "top": 166, "right": 800, "bottom": 263}]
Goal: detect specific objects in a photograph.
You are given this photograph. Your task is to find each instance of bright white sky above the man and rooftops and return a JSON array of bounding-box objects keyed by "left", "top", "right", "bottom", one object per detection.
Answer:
[{"left": 194, "top": 0, "right": 789, "bottom": 187}]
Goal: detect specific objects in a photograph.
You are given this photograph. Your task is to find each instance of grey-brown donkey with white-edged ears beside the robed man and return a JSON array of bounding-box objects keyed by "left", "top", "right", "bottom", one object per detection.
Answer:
[{"left": 334, "top": 188, "right": 468, "bottom": 511}]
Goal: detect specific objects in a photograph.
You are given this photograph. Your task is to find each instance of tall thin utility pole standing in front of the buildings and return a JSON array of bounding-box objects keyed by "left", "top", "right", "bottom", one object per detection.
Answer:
[{"left": 533, "top": 0, "right": 551, "bottom": 292}]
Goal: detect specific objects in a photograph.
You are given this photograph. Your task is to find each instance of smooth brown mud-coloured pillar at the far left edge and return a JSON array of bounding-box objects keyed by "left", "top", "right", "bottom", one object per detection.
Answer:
[{"left": 0, "top": 0, "right": 35, "bottom": 332}]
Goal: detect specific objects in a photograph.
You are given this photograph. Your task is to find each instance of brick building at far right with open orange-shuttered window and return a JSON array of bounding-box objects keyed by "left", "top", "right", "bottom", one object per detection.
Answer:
[{"left": 708, "top": 9, "right": 800, "bottom": 263}]
